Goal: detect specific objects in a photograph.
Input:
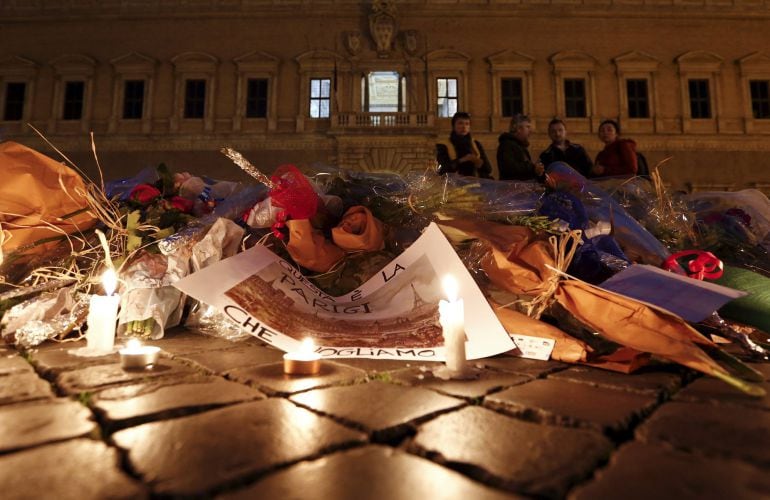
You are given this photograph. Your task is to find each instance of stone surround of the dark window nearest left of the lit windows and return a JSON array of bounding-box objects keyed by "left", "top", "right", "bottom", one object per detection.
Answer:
[{"left": 233, "top": 51, "right": 280, "bottom": 131}]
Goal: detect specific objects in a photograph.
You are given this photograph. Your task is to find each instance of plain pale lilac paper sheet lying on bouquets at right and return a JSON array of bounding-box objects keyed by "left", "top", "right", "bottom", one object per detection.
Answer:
[{"left": 599, "top": 264, "right": 746, "bottom": 323}]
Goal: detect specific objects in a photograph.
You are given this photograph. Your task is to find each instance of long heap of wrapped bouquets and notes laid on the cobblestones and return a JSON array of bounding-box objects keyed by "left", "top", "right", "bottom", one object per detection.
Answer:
[{"left": 0, "top": 143, "right": 770, "bottom": 395}]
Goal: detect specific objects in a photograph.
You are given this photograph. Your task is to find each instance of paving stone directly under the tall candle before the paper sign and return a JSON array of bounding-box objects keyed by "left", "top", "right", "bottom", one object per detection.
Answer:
[{"left": 390, "top": 369, "right": 532, "bottom": 399}]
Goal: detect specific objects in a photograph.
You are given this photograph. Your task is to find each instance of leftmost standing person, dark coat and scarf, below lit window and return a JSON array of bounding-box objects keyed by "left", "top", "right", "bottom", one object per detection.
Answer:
[{"left": 436, "top": 111, "right": 492, "bottom": 179}]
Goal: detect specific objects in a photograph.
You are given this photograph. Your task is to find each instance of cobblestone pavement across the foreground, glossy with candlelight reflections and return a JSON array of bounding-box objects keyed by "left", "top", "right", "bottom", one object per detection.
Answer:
[{"left": 0, "top": 329, "right": 770, "bottom": 500}]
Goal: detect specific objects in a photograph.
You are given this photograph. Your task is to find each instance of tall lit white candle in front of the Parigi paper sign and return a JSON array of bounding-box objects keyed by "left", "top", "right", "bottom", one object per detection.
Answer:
[{"left": 438, "top": 275, "right": 465, "bottom": 373}]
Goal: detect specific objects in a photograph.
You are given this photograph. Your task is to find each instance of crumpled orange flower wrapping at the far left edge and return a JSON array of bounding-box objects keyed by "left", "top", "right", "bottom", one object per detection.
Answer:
[{"left": 0, "top": 141, "right": 95, "bottom": 253}]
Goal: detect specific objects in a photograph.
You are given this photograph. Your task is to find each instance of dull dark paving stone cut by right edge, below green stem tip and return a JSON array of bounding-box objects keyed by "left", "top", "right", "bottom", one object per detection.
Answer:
[{"left": 636, "top": 402, "right": 770, "bottom": 467}]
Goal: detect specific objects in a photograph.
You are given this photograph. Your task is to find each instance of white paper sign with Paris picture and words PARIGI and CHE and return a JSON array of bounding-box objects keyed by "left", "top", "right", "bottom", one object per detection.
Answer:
[{"left": 174, "top": 224, "right": 514, "bottom": 361}]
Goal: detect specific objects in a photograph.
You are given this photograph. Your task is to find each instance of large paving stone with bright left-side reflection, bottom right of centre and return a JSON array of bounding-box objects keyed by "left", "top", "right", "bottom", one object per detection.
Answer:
[{"left": 411, "top": 406, "right": 613, "bottom": 498}]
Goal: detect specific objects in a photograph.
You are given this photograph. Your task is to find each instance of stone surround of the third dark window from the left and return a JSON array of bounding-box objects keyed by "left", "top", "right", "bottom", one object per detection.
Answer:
[{"left": 107, "top": 52, "right": 158, "bottom": 134}]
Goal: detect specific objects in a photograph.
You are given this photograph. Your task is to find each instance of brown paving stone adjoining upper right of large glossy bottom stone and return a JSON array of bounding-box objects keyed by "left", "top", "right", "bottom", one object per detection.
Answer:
[{"left": 484, "top": 379, "right": 657, "bottom": 435}]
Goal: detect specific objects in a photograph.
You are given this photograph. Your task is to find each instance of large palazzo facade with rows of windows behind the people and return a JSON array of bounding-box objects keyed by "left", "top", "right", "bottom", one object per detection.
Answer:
[{"left": 0, "top": 0, "right": 770, "bottom": 190}]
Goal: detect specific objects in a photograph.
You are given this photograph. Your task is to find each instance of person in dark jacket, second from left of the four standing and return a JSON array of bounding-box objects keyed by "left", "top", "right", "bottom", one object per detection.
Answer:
[{"left": 497, "top": 113, "right": 545, "bottom": 182}]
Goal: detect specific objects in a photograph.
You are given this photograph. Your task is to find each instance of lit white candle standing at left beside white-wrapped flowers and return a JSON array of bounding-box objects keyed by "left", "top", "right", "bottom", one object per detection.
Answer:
[{"left": 86, "top": 268, "right": 120, "bottom": 354}]
